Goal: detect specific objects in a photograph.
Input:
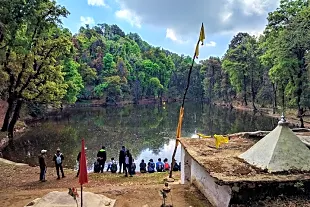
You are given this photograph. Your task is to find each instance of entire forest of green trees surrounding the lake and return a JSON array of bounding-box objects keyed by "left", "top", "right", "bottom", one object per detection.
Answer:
[{"left": 0, "top": 0, "right": 310, "bottom": 137}]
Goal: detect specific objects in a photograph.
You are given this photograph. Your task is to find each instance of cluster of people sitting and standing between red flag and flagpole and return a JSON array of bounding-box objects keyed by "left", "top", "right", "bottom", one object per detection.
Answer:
[{"left": 94, "top": 146, "right": 181, "bottom": 177}]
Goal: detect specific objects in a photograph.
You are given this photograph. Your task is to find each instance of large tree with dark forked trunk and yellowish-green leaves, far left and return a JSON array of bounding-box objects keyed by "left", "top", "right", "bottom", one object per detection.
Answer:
[{"left": 0, "top": 0, "right": 72, "bottom": 138}]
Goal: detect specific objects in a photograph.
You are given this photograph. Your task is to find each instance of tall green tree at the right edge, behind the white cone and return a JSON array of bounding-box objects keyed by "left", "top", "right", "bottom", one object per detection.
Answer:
[{"left": 265, "top": 0, "right": 310, "bottom": 127}]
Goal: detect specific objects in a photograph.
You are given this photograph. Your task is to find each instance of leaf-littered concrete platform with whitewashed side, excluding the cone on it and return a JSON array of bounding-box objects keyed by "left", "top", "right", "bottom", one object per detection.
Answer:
[{"left": 179, "top": 138, "right": 310, "bottom": 207}]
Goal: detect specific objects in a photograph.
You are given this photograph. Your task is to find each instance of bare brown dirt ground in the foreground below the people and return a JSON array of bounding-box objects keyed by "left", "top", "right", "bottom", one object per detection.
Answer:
[{"left": 0, "top": 162, "right": 211, "bottom": 207}]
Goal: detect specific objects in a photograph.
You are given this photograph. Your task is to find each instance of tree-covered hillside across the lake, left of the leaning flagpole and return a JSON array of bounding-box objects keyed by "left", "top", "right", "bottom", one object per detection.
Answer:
[{"left": 69, "top": 24, "right": 191, "bottom": 103}]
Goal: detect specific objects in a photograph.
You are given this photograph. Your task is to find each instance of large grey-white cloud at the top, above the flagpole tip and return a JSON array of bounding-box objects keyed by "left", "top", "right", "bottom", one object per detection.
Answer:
[{"left": 117, "top": 0, "right": 280, "bottom": 41}]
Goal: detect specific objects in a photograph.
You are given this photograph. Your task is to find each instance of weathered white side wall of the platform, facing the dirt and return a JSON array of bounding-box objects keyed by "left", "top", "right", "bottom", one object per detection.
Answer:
[{"left": 181, "top": 146, "right": 231, "bottom": 207}]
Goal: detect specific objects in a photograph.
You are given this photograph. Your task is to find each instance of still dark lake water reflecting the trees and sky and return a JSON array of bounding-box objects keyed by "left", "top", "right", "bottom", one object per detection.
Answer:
[{"left": 3, "top": 102, "right": 277, "bottom": 170}]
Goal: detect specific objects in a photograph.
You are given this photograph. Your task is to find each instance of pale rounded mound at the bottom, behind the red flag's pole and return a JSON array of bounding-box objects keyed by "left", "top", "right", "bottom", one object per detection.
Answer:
[{"left": 25, "top": 191, "right": 116, "bottom": 207}]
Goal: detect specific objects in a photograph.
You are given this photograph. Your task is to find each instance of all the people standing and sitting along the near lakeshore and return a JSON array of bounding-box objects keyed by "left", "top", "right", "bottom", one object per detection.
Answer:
[{"left": 39, "top": 146, "right": 181, "bottom": 182}]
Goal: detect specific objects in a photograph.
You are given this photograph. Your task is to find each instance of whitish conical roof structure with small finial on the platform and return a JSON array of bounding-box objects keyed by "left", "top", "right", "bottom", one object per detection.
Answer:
[{"left": 239, "top": 115, "right": 310, "bottom": 172}]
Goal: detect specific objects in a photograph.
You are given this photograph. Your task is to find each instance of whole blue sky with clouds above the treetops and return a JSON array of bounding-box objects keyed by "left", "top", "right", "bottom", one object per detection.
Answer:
[{"left": 57, "top": 0, "right": 280, "bottom": 60}]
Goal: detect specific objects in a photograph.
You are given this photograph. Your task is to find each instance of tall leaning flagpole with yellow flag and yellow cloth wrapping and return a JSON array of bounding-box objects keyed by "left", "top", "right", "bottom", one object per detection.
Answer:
[{"left": 169, "top": 24, "right": 204, "bottom": 178}]
